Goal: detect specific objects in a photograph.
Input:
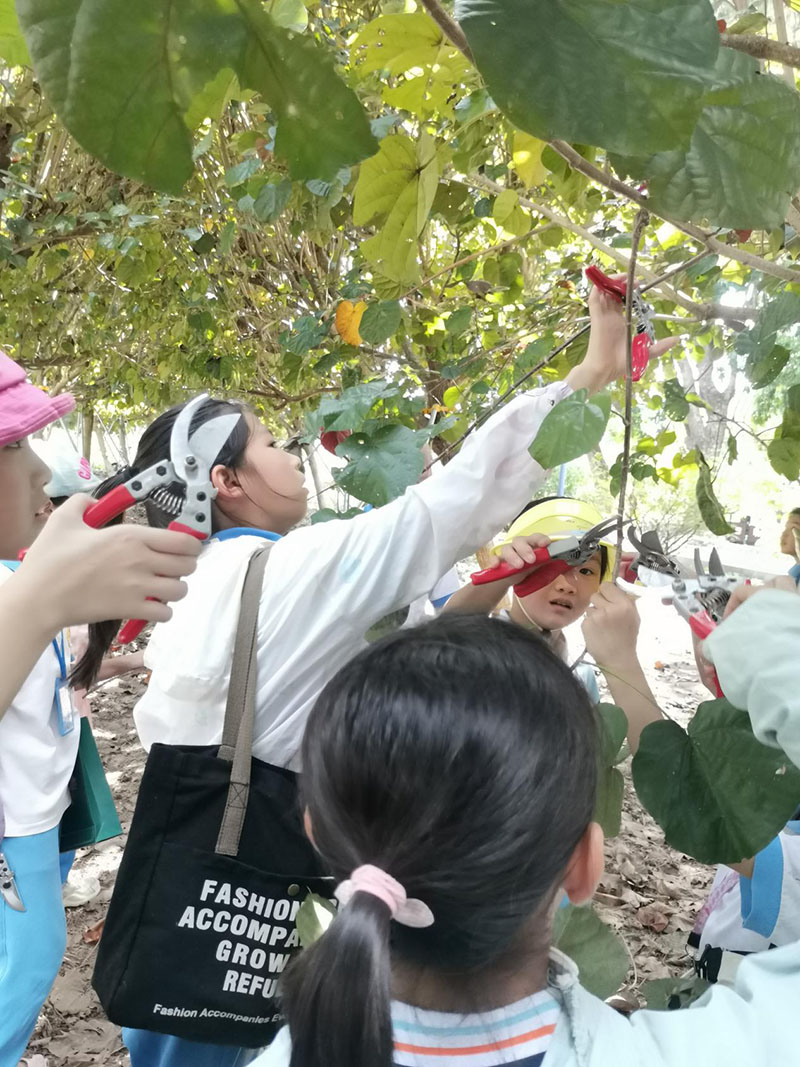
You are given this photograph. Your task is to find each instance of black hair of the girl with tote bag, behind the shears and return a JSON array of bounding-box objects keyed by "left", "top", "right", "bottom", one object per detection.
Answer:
[{"left": 69, "top": 397, "right": 251, "bottom": 689}]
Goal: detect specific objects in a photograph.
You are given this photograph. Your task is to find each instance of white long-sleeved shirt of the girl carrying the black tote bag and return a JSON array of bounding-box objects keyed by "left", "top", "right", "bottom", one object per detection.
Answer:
[{"left": 134, "top": 382, "right": 572, "bottom": 768}]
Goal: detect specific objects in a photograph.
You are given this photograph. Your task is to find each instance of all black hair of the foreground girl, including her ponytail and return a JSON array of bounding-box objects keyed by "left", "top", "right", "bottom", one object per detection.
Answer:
[{"left": 283, "top": 616, "right": 597, "bottom": 1067}]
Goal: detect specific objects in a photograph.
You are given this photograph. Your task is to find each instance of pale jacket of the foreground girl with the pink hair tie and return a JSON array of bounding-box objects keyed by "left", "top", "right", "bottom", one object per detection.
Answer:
[{"left": 254, "top": 591, "right": 800, "bottom": 1067}]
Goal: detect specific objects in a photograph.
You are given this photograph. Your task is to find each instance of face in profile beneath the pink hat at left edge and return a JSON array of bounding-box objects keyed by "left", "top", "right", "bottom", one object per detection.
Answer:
[{"left": 0, "top": 437, "right": 50, "bottom": 559}]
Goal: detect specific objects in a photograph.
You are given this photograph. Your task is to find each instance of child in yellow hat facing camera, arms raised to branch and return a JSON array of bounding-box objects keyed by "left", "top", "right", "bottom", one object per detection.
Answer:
[{"left": 444, "top": 496, "right": 660, "bottom": 751}]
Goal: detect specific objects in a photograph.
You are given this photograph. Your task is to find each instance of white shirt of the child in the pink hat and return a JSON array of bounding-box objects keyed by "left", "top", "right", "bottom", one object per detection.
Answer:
[{"left": 0, "top": 566, "right": 80, "bottom": 838}]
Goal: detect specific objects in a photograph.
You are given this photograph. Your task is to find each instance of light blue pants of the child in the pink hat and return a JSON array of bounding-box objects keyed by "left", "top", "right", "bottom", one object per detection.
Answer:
[{"left": 0, "top": 826, "right": 66, "bottom": 1067}]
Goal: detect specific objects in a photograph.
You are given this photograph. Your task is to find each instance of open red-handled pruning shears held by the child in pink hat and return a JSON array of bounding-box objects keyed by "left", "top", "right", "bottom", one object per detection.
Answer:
[{"left": 83, "top": 393, "right": 241, "bottom": 644}]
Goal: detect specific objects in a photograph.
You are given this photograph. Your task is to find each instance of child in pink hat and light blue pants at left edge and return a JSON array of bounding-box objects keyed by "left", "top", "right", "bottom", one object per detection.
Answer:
[{"left": 0, "top": 353, "right": 196, "bottom": 1067}]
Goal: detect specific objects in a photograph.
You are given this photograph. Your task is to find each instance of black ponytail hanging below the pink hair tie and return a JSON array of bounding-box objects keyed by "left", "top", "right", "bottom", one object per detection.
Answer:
[{"left": 282, "top": 893, "right": 393, "bottom": 1067}]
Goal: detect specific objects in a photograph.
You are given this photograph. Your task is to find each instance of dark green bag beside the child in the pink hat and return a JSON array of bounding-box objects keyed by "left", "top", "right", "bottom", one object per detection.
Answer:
[{"left": 59, "top": 718, "right": 123, "bottom": 853}]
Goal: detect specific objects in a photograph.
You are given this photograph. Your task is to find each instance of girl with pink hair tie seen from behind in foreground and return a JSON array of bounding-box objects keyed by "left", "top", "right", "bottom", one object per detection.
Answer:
[{"left": 256, "top": 591, "right": 800, "bottom": 1067}]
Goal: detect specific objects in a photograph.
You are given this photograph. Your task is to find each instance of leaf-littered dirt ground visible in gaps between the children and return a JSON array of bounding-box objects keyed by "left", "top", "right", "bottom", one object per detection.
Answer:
[{"left": 28, "top": 604, "right": 713, "bottom": 1067}]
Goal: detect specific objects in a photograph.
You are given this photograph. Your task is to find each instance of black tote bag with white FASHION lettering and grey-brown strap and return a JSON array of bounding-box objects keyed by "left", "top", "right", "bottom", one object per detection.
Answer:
[{"left": 93, "top": 546, "right": 333, "bottom": 1048}]
